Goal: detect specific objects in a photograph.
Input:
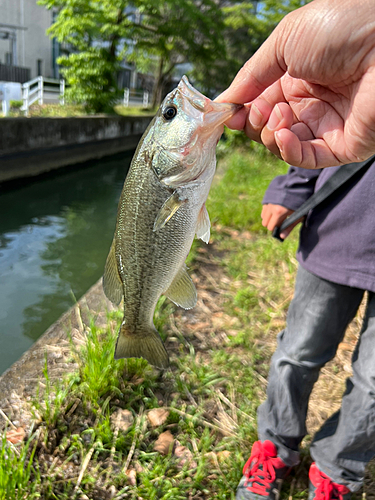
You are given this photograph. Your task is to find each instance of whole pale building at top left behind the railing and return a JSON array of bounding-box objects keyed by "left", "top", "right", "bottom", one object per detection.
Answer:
[{"left": 0, "top": 0, "right": 58, "bottom": 83}]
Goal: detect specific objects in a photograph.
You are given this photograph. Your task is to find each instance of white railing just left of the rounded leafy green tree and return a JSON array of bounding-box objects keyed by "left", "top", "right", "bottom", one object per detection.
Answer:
[{"left": 21, "top": 76, "right": 65, "bottom": 116}]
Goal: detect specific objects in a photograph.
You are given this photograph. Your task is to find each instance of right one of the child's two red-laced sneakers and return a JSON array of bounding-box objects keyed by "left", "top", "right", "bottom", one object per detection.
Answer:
[{"left": 309, "top": 462, "right": 351, "bottom": 500}]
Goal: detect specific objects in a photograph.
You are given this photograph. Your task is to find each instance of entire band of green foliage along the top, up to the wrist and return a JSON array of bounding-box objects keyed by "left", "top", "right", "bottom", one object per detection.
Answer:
[{"left": 38, "top": 0, "right": 314, "bottom": 112}]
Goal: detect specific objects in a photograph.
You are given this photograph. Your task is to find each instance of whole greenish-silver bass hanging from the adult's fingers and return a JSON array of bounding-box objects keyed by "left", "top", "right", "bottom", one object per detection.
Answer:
[{"left": 103, "top": 76, "right": 242, "bottom": 368}]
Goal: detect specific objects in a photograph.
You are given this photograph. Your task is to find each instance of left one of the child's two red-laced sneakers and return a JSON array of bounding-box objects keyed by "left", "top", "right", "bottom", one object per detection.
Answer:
[{"left": 236, "top": 441, "right": 290, "bottom": 500}]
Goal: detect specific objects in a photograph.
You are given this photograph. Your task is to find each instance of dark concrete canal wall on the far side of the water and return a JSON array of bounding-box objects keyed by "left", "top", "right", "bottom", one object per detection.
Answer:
[{"left": 0, "top": 116, "right": 151, "bottom": 182}]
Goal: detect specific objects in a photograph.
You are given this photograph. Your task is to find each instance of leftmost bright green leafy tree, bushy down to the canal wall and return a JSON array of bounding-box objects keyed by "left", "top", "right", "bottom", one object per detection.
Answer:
[{"left": 38, "top": 0, "right": 129, "bottom": 112}]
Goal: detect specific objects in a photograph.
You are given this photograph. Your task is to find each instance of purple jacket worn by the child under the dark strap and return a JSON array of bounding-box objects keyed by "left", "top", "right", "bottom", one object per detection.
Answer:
[{"left": 263, "top": 162, "right": 375, "bottom": 292}]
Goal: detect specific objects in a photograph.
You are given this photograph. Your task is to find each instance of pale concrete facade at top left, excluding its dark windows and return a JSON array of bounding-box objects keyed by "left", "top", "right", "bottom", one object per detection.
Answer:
[{"left": 0, "top": 0, "right": 54, "bottom": 79}]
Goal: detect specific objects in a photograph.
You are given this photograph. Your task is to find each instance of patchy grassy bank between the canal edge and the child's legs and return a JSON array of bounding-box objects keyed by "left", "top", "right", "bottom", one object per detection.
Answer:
[{"left": 0, "top": 139, "right": 371, "bottom": 500}]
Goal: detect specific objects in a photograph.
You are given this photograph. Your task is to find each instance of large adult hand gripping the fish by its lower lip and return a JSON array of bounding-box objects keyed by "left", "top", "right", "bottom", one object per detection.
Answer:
[{"left": 217, "top": 0, "right": 375, "bottom": 168}]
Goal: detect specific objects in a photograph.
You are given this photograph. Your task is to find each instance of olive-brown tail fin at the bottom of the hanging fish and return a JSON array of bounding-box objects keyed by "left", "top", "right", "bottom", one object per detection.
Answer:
[{"left": 115, "top": 323, "right": 169, "bottom": 368}]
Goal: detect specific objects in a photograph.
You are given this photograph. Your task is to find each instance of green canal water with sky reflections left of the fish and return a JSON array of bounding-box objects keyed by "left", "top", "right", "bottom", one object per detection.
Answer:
[{"left": 0, "top": 155, "right": 131, "bottom": 373}]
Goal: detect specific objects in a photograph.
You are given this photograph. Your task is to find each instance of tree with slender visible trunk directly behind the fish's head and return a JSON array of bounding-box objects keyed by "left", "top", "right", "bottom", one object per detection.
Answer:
[{"left": 128, "top": 0, "right": 226, "bottom": 105}]
